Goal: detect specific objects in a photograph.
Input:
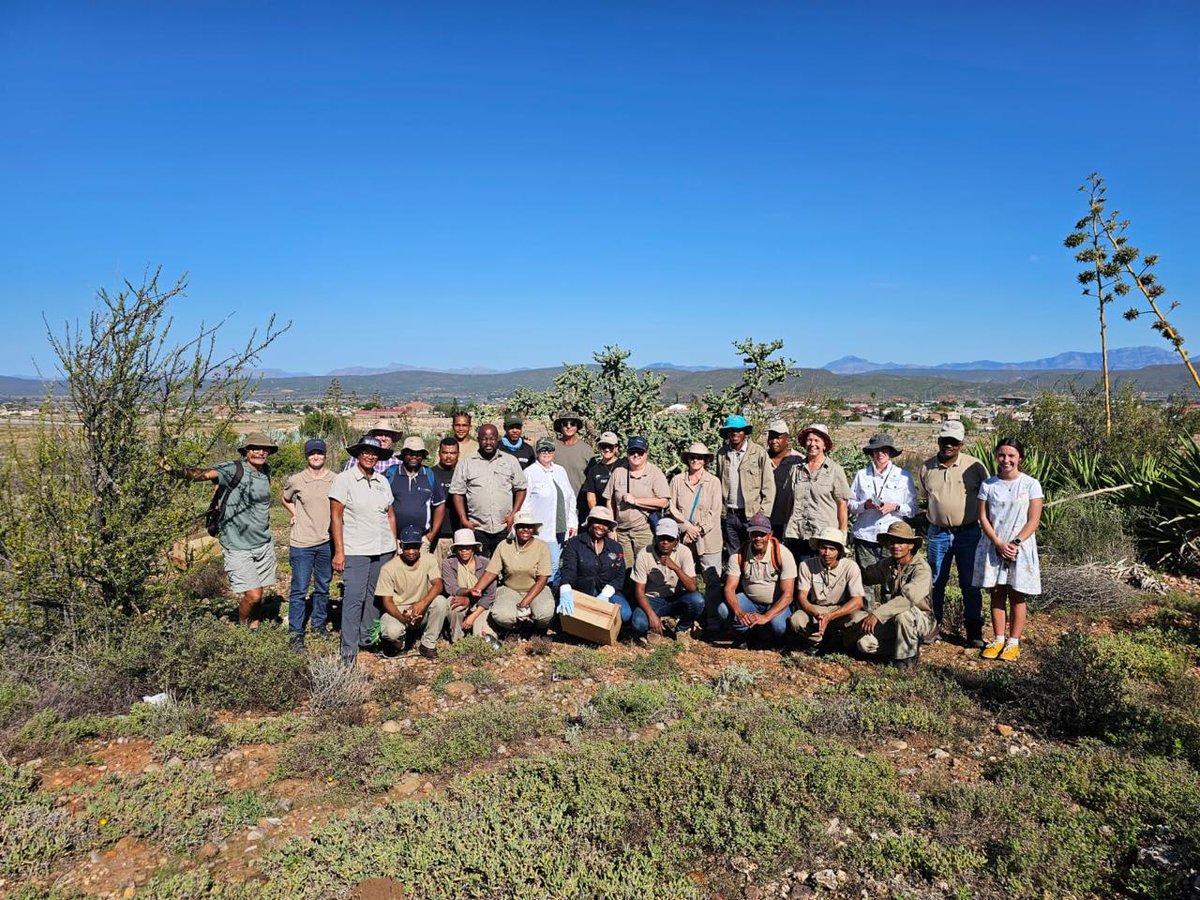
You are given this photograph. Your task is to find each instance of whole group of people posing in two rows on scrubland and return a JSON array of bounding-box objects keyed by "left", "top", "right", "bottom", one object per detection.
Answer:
[{"left": 184, "top": 412, "right": 1042, "bottom": 666}]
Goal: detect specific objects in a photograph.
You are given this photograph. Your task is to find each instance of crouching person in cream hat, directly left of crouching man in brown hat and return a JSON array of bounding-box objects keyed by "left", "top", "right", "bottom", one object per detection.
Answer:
[{"left": 787, "top": 528, "right": 864, "bottom": 653}]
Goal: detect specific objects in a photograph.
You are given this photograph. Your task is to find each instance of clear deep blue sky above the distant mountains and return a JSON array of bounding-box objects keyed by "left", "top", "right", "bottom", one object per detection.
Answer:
[{"left": 0, "top": 0, "right": 1200, "bottom": 374}]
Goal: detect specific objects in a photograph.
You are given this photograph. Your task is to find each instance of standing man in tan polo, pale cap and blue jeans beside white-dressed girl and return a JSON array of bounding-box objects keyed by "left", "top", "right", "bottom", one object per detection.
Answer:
[{"left": 917, "top": 420, "right": 988, "bottom": 648}]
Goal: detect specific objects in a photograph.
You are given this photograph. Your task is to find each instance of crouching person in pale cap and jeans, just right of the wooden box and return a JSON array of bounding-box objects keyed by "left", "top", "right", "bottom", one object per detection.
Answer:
[{"left": 629, "top": 518, "right": 704, "bottom": 638}]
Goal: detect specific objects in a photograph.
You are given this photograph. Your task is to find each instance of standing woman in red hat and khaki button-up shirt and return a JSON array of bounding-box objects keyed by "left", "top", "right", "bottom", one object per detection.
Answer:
[{"left": 784, "top": 425, "right": 850, "bottom": 559}]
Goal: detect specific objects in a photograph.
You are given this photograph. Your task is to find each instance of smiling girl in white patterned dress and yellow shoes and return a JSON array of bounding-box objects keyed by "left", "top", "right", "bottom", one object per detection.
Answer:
[{"left": 974, "top": 438, "right": 1043, "bottom": 662}]
